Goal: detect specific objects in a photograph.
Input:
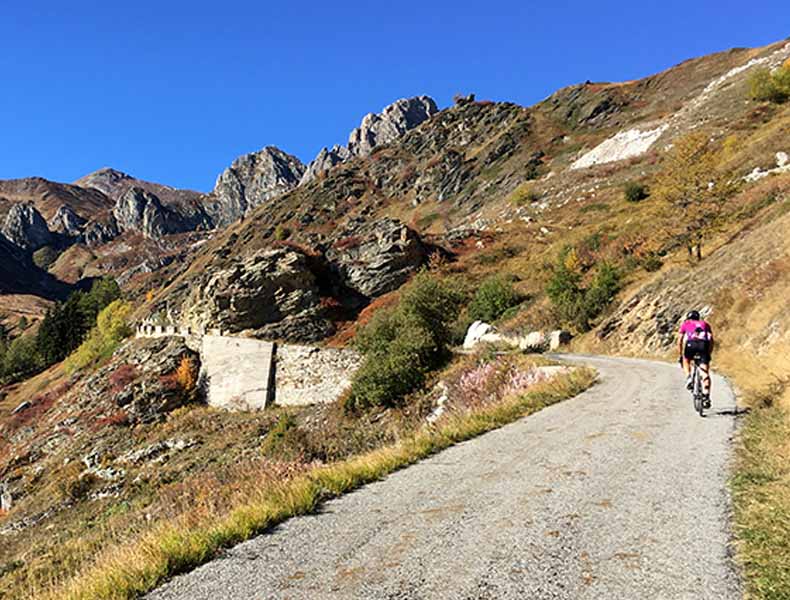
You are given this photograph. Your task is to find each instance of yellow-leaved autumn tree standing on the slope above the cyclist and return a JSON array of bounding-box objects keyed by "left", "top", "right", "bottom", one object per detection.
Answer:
[{"left": 652, "top": 131, "right": 737, "bottom": 260}]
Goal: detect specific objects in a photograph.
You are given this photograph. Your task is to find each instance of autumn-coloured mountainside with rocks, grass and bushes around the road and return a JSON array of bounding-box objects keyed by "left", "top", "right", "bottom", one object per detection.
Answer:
[{"left": 0, "top": 42, "right": 790, "bottom": 598}]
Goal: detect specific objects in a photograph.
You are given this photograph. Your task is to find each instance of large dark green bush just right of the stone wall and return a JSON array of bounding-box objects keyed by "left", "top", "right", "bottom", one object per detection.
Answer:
[{"left": 344, "top": 271, "right": 463, "bottom": 410}]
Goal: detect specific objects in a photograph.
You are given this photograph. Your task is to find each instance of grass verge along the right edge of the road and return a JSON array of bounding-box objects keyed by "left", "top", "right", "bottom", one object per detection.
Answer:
[{"left": 730, "top": 388, "right": 790, "bottom": 600}]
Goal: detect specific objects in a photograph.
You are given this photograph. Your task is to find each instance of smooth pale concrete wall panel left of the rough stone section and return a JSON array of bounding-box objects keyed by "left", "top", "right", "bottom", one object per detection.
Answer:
[{"left": 200, "top": 335, "right": 273, "bottom": 410}]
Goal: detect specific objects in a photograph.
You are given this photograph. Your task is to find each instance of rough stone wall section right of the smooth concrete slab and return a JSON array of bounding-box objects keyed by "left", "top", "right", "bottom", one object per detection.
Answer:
[{"left": 274, "top": 344, "right": 362, "bottom": 406}]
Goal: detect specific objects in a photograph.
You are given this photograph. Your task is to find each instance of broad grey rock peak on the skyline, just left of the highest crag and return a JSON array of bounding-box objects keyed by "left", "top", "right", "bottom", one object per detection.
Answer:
[{"left": 213, "top": 146, "right": 305, "bottom": 226}]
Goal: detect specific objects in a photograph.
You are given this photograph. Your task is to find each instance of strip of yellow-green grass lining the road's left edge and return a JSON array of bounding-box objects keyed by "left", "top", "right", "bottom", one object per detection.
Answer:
[{"left": 41, "top": 368, "right": 595, "bottom": 600}]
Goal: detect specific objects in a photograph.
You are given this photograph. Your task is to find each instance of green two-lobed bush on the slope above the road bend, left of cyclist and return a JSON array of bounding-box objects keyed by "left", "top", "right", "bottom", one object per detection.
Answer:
[{"left": 546, "top": 248, "right": 620, "bottom": 331}]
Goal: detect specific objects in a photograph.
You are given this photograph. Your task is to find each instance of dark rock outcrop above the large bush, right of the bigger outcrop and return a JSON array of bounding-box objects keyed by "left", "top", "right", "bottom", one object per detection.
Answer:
[{"left": 326, "top": 219, "right": 428, "bottom": 298}]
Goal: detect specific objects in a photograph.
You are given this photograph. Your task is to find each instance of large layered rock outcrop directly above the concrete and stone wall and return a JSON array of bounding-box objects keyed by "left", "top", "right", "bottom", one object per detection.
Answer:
[{"left": 183, "top": 248, "right": 332, "bottom": 341}]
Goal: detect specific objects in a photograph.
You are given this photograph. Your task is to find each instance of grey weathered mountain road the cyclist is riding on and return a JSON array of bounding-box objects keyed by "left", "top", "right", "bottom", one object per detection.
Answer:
[{"left": 148, "top": 357, "right": 741, "bottom": 600}]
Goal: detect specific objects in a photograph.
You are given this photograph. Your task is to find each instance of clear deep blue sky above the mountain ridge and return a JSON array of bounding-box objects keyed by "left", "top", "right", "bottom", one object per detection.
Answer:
[{"left": 0, "top": 0, "right": 790, "bottom": 191}]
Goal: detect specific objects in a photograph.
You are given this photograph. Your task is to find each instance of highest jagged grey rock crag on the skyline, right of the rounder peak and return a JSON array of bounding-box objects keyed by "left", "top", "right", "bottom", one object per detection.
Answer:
[{"left": 301, "top": 96, "right": 439, "bottom": 183}]
